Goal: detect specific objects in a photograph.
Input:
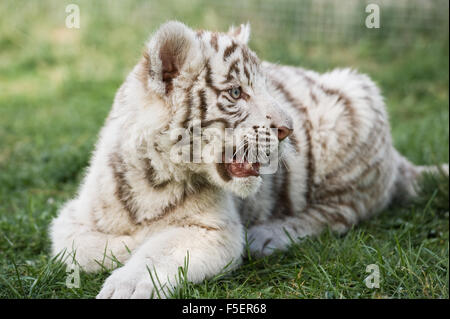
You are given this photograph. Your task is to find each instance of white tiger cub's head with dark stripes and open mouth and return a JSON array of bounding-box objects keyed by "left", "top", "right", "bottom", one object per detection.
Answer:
[{"left": 135, "top": 22, "right": 293, "bottom": 197}]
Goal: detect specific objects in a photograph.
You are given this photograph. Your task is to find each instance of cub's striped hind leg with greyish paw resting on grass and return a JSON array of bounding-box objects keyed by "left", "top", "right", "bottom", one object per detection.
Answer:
[{"left": 247, "top": 204, "right": 358, "bottom": 256}]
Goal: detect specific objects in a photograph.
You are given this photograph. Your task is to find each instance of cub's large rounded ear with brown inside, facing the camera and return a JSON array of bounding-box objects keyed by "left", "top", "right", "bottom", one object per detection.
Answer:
[{"left": 144, "top": 21, "right": 199, "bottom": 95}]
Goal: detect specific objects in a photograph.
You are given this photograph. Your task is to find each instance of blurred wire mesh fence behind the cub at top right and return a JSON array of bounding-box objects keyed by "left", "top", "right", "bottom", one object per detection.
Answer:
[{"left": 209, "top": 0, "right": 449, "bottom": 46}]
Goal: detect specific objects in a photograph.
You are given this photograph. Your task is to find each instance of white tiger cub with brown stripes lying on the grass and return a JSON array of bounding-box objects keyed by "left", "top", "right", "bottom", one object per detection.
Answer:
[{"left": 50, "top": 22, "right": 448, "bottom": 298}]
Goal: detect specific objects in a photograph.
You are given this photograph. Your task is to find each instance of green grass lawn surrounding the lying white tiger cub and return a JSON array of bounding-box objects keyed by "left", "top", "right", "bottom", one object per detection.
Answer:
[{"left": 0, "top": 1, "right": 449, "bottom": 298}]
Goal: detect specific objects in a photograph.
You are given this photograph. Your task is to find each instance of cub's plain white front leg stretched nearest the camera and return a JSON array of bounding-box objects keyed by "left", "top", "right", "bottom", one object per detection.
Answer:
[{"left": 97, "top": 223, "right": 243, "bottom": 299}]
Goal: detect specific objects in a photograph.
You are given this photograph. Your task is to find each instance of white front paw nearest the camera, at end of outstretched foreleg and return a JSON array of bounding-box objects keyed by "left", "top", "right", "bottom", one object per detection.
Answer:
[{"left": 97, "top": 265, "right": 167, "bottom": 299}]
